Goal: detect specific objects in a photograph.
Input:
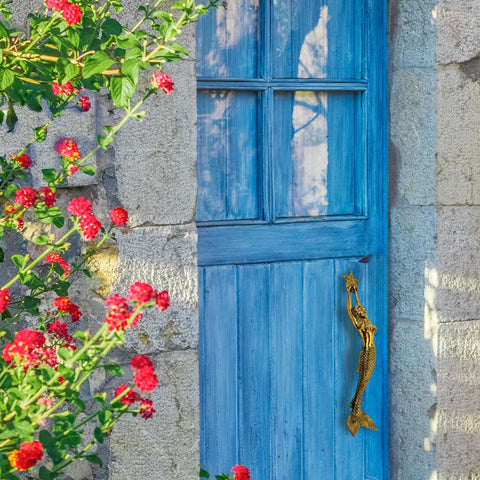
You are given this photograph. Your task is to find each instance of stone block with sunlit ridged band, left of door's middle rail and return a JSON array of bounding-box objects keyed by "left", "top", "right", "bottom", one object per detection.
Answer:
[{"left": 118, "top": 224, "right": 198, "bottom": 353}]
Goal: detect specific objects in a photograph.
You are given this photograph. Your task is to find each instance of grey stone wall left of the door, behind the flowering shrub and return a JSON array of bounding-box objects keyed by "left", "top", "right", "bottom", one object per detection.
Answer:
[{"left": 4, "top": 0, "right": 199, "bottom": 480}]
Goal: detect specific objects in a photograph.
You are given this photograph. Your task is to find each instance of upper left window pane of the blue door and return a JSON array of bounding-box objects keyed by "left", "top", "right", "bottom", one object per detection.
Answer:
[{"left": 197, "top": 0, "right": 259, "bottom": 78}]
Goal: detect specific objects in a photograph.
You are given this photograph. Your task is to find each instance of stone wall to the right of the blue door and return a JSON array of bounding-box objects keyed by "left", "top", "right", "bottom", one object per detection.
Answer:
[{"left": 390, "top": 0, "right": 480, "bottom": 480}]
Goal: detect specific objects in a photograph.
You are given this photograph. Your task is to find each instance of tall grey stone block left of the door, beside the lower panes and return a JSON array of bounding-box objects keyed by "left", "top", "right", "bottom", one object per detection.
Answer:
[{"left": 114, "top": 62, "right": 197, "bottom": 225}]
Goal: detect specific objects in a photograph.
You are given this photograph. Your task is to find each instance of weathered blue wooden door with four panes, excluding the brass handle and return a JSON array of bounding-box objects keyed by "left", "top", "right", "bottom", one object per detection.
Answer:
[{"left": 196, "top": 0, "right": 388, "bottom": 480}]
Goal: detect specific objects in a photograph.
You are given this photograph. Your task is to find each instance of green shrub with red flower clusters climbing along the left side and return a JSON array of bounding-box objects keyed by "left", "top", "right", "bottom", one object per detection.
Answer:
[{"left": 0, "top": 0, "right": 225, "bottom": 480}]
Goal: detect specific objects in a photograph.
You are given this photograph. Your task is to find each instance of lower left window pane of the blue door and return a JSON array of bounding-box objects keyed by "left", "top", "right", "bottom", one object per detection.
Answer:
[{"left": 196, "top": 90, "right": 258, "bottom": 221}]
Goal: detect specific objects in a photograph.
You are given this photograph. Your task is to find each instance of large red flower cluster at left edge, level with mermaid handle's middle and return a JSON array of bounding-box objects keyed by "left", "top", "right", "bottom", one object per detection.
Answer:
[{"left": 3, "top": 328, "right": 58, "bottom": 369}]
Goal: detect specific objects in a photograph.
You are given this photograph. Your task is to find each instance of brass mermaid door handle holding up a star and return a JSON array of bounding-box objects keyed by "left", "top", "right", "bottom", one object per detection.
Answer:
[{"left": 342, "top": 270, "right": 377, "bottom": 436}]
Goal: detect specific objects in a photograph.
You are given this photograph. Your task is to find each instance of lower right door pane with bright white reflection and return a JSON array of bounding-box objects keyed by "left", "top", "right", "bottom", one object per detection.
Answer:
[{"left": 273, "top": 92, "right": 357, "bottom": 218}]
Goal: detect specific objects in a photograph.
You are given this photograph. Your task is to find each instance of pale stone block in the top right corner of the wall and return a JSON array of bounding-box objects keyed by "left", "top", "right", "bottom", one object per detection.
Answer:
[{"left": 437, "top": 0, "right": 480, "bottom": 64}]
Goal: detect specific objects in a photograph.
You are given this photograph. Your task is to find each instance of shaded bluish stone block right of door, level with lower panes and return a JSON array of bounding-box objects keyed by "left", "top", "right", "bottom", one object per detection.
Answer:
[{"left": 390, "top": 69, "right": 437, "bottom": 205}]
